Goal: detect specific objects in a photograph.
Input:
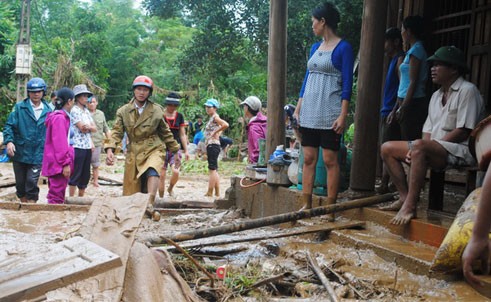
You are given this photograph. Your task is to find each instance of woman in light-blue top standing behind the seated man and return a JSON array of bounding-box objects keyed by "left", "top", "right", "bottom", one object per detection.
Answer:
[{"left": 397, "top": 16, "right": 429, "bottom": 141}]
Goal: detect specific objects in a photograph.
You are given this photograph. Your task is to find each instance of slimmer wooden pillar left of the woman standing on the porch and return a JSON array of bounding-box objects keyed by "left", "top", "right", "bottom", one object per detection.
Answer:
[{"left": 266, "top": 0, "right": 288, "bottom": 159}]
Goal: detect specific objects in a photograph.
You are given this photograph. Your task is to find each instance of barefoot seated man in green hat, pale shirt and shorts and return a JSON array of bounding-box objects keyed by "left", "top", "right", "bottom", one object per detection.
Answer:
[{"left": 381, "top": 46, "right": 484, "bottom": 225}]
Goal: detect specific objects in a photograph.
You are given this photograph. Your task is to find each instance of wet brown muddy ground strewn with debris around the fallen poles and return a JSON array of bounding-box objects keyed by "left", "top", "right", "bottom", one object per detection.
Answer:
[{"left": 0, "top": 157, "right": 486, "bottom": 301}]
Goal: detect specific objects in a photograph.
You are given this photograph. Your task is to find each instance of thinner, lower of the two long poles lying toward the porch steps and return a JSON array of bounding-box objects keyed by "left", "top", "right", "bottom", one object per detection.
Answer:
[{"left": 158, "top": 222, "right": 365, "bottom": 252}]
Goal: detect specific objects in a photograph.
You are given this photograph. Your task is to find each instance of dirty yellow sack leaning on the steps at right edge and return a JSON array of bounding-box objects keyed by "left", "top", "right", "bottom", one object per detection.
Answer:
[{"left": 430, "top": 188, "right": 491, "bottom": 274}]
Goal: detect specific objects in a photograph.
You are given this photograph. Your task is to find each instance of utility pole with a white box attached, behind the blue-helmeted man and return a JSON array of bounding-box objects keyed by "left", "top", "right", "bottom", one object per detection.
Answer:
[{"left": 15, "top": 0, "right": 32, "bottom": 102}]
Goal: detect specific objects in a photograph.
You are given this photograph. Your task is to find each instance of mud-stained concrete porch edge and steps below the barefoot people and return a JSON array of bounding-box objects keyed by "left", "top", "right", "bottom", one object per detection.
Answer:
[{"left": 225, "top": 177, "right": 464, "bottom": 279}]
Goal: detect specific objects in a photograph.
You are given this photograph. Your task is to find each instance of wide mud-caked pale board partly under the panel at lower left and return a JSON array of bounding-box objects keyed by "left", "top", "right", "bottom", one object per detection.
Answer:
[{"left": 47, "top": 193, "right": 148, "bottom": 302}]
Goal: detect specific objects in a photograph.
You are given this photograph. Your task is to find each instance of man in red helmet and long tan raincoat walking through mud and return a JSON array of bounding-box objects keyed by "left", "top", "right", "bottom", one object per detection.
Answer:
[{"left": 104, "top": 75, "right": 179, "bottom": 206}]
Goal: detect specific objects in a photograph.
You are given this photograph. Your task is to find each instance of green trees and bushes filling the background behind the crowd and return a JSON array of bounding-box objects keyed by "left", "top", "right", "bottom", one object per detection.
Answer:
[{"left": 0, "top": 0, "right": 363, "bottom": 141}]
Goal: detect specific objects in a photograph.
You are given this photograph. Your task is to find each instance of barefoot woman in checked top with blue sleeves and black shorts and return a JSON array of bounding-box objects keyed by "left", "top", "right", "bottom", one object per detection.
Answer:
[{"left": 294, "top": 2, "right": 353, "bottom": 221}]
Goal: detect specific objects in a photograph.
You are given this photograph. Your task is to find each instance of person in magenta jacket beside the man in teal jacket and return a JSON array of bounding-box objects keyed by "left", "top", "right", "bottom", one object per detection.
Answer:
[{"left": 41, "top": 87, "right": 75, "bottom": 204}]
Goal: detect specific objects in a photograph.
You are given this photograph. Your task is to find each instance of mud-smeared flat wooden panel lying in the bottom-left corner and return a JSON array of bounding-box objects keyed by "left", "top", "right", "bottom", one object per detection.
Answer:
[{"left": 0, "top": 237, "right": 121, "bottom": 302}]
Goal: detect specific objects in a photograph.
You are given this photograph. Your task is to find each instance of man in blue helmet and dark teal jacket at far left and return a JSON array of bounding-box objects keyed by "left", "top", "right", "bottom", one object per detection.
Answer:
[{"left": 3, "top": 78, "right": 51, "bottom": 203}]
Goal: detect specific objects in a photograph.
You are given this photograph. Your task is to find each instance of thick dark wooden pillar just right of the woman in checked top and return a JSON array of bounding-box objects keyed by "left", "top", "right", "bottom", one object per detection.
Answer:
[{"left": 350, "top": 0, "right": 388, "bottom": 191}]
